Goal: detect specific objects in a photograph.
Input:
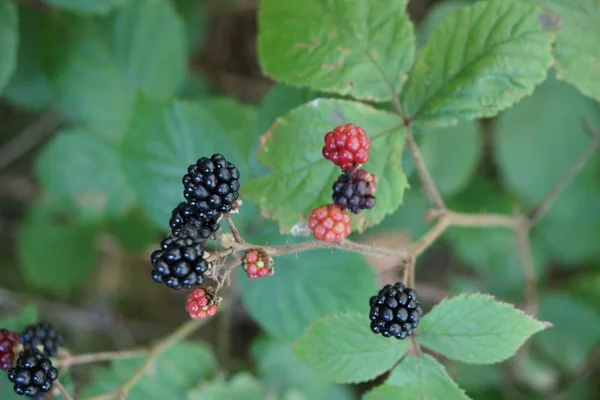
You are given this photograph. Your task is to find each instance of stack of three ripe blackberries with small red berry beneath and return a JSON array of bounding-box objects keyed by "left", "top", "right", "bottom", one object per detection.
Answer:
[{"left": 150, "top": 154, "right": 240, "bottom": 319}]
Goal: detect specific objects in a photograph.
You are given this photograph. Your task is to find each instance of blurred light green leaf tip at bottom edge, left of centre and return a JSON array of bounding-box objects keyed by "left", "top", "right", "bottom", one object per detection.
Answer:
[{"left": 187, "top": 372, "right": 265, "bottom": 400}]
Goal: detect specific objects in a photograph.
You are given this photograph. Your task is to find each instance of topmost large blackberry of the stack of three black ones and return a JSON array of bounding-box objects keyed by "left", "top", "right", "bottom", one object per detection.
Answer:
[{"left": 182, "top": 154, "right": 240, "bottom": 218}]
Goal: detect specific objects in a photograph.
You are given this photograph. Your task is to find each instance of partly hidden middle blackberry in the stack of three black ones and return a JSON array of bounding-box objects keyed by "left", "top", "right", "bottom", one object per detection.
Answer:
[{"left": 169, "top": 202, "right": 221, "bottom": 239}]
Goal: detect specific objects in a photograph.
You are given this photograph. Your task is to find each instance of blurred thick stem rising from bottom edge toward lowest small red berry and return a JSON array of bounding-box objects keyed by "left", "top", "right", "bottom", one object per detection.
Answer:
[{"left": 82, "top": 319, "right": 206, "bottom": 400}]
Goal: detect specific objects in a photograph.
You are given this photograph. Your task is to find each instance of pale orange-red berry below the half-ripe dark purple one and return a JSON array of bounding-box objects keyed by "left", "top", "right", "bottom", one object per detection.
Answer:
[{"left": 308, "top": 204, "right": 352, "bottom": 243}]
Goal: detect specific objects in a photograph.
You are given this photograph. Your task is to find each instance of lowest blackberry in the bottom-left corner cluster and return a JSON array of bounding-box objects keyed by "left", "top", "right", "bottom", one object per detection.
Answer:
[{"left": 8, "top": 347, "right": 58, "bottom": 398}]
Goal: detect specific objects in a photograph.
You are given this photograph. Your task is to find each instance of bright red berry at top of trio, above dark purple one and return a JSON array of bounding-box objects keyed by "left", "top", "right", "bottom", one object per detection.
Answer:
[{"left": 323, "top": 124, "right": 371, "bottom": 171}]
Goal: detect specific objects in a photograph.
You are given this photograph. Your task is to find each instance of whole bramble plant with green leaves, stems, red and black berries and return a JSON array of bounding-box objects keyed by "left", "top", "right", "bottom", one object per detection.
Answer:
[{"left": 0, "top": 0, "right": 600, "bottom": 400}]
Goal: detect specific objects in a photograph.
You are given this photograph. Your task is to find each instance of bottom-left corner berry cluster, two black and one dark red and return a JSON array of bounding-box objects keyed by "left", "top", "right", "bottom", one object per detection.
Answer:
[{"left": 0, "top": 322, "right": 64, "bottom": 399}]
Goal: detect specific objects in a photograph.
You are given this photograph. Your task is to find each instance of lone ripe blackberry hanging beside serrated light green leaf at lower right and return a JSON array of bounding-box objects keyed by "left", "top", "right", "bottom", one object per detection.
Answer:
[{"left": 369, "top": 282, "right": 423, "bottom": 339}]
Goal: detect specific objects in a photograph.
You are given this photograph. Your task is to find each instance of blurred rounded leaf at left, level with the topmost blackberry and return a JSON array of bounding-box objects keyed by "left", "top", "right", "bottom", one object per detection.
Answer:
[{"left": 36, "top": 130, "right": 135, "bottom": 219}]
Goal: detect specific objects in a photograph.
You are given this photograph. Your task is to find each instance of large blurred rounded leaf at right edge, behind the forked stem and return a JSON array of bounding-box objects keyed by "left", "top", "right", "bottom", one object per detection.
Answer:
[{"left": 492, "top": 74, "right": 600, "bottom": 206}]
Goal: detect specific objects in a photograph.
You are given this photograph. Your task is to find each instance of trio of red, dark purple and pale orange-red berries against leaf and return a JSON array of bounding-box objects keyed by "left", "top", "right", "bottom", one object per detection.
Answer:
[{"left": 308, "top": 124, "right": 377, "bottom": 243}]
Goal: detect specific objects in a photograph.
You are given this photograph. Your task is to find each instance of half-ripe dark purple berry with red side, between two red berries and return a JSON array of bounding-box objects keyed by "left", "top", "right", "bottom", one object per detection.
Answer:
[{"left": 331, "top": 168, "right": 377, "bottom": 214}]
